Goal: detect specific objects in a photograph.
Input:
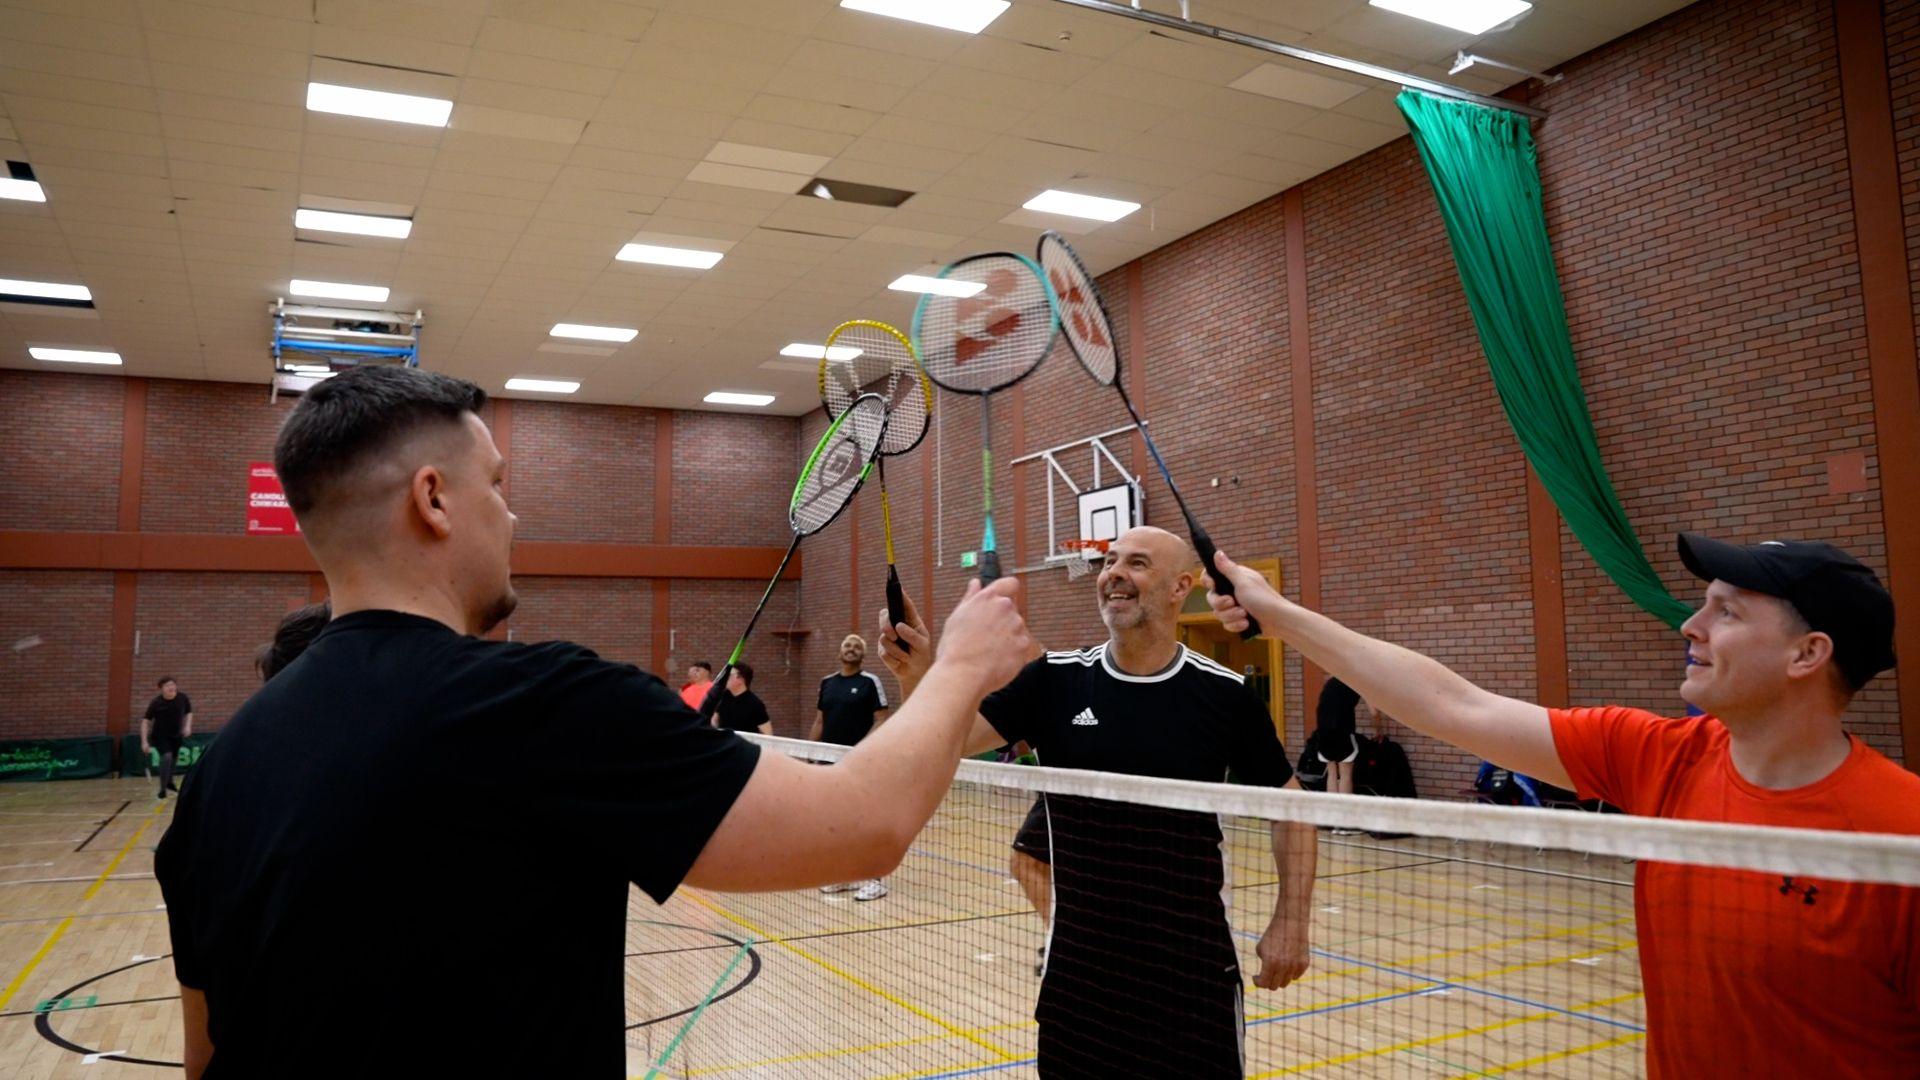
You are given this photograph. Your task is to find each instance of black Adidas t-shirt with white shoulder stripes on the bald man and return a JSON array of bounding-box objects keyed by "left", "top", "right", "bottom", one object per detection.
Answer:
[{"left": 979, "top": 644, "right": 1294, "bottom": 1032}]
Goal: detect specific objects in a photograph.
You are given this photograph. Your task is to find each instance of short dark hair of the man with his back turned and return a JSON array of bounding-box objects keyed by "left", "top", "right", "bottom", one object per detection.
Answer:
[{"left": 273, "top": 365, "right": 486, "bottom": 515}]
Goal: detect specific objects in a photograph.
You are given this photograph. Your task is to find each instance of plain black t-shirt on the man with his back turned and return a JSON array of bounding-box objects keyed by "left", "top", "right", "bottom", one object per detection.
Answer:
[{"left": 154, "top": 611, "right": 760, "bottom": 1080}]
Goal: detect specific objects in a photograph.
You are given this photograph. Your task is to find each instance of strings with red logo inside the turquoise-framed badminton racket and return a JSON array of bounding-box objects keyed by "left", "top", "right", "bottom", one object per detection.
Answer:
[{"left": 914, "top": 252, "right": 1060, "bottom": 394}]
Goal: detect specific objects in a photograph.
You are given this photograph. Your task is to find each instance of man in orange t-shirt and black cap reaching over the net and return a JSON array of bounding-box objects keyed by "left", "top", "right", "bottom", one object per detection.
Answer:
[{"left": 1208, "top": 534, "right": 1920, "bottom": 1078}]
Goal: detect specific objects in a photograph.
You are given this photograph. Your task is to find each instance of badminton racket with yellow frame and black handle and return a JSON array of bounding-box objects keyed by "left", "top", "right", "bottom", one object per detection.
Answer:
[{"left": 820, "top": 319, "right": 933, "bottom": 651}]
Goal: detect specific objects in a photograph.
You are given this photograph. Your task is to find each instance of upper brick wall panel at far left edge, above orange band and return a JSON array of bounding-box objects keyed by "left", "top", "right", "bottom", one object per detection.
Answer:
[{"left": 0, "top": 371, "right": 123, "bottom": 528}]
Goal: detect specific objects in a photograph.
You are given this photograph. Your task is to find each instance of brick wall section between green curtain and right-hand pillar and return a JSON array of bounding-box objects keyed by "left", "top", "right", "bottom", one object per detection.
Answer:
[{"left": 1538, "top": 0, "right": 1901, "bottom": 757}]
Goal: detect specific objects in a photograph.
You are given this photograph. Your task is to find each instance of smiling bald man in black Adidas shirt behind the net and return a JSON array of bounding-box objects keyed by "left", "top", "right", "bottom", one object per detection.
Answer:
[{"left": 879, "top": 528, "right": 1315, "bottom": 1076}]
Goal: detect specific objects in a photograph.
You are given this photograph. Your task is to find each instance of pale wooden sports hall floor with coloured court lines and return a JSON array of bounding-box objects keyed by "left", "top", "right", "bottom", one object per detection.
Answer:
[{"left": 0, "top": 780, "right": 1644, "bottom": 1080}]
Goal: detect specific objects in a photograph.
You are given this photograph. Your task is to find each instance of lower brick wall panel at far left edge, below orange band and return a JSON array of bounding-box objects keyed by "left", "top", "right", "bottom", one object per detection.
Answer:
[{"left": 0, "top": 568, "right": 113, "bottom": 740}]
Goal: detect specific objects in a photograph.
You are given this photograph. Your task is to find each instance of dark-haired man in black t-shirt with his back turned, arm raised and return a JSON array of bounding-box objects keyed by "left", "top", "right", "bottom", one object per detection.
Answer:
[{"left": 154, "top": 367, "right": 1029, "bottom": 1080}]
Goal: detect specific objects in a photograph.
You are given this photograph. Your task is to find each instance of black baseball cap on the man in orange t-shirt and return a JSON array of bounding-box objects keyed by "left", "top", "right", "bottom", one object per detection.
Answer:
[{"left": 1680, "top": 532, "right": 1893, "bottom": 690}]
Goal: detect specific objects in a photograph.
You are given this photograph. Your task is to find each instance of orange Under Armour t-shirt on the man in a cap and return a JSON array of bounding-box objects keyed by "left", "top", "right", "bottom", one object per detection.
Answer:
[{"left": 1549, "top": 707, "right": 1920, "bottom": 1078}]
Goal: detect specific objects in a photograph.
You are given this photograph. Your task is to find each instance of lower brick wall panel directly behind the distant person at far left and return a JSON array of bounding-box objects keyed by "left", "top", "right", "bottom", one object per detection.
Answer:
[{"left": 129, "top": 573, "right": 307, "bottom": 732}]
